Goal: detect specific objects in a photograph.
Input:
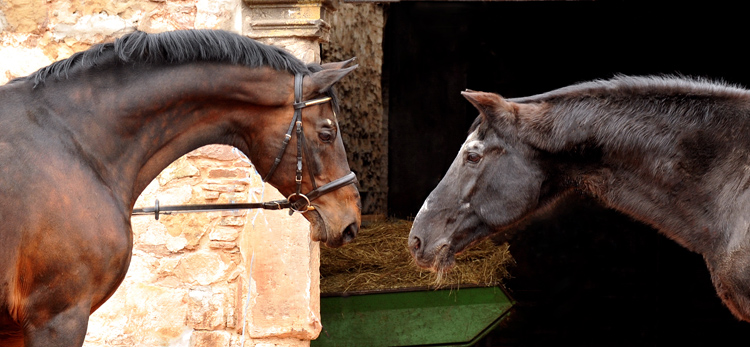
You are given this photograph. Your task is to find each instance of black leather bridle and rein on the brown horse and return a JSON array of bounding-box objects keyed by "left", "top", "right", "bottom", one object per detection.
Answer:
[{"left": 132, "top": 74, "right": 357, "bottom": 220}]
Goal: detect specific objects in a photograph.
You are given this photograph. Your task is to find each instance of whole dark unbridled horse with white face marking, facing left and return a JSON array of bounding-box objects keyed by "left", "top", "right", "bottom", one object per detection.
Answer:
[{"left": 408, "top": 76, "right": 750, "bottom": 322}]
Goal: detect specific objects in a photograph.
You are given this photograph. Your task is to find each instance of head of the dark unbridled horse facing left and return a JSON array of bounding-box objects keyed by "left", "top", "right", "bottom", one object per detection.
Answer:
[{"left": 408, "top": 91, "right": 545, "bottom": 271}]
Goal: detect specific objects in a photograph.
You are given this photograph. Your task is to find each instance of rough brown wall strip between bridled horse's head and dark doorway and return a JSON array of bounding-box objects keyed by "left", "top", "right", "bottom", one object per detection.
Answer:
[{"left": 321, "top": 2, "right": 388, "bottom": 214}]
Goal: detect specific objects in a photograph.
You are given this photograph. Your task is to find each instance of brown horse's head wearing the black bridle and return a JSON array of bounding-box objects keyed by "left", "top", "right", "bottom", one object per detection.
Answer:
[{"left": 251, "top": 60, "right": 361, "bottom": 247}]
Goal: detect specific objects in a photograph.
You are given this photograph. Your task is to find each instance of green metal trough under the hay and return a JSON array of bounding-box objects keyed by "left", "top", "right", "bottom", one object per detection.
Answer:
[{"left": 311, "top": 287, "right": 514, "bottom": 347}]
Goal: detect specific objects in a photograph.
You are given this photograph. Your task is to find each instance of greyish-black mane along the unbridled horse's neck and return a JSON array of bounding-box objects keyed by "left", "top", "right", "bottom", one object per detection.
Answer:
[{"left": 502, "top": 76, "right": 750, "bottom": 152}]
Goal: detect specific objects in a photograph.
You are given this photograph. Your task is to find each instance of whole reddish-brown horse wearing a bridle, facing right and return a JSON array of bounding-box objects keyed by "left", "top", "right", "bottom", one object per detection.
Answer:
[{"left": 0, "top": 30, "right": 361, "bottom": 347}]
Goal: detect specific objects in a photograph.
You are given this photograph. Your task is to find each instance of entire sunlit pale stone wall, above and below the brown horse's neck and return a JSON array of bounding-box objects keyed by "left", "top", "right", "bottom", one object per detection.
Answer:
[{"left": 0, "top": 0, "right": 327, "bottom": 347}]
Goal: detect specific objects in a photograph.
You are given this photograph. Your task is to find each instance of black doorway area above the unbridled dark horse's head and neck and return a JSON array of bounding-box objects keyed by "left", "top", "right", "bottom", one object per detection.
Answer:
[{"left": 390, "top": 1, "right": 750, "bottom": 217}]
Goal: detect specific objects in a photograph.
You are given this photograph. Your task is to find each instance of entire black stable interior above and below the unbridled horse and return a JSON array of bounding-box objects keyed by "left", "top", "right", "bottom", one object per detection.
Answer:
[{"left": 383, "top": 1, "right": 750, "bottom": 346}]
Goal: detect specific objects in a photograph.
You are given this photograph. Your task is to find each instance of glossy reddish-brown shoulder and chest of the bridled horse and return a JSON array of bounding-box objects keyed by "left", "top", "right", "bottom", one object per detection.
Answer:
[{"left": 0, "top": 103, "right": 132, "bottom": 329}]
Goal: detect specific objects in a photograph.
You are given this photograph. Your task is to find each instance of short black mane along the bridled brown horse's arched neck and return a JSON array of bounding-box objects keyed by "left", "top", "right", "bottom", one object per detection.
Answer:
[{"left": 11, "top": 30, "right": 310, "bottom": 87}]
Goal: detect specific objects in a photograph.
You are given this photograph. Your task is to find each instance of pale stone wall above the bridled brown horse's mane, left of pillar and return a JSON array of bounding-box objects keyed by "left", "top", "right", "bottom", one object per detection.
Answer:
[{"left": 0, "top": 0, "right": 241, "bottom": 84}]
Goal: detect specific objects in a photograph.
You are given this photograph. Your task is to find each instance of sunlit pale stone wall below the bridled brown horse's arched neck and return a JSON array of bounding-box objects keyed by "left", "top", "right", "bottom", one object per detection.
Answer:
[{"left": 85, "top": 145, "right": 320, "bottom": 347}]
